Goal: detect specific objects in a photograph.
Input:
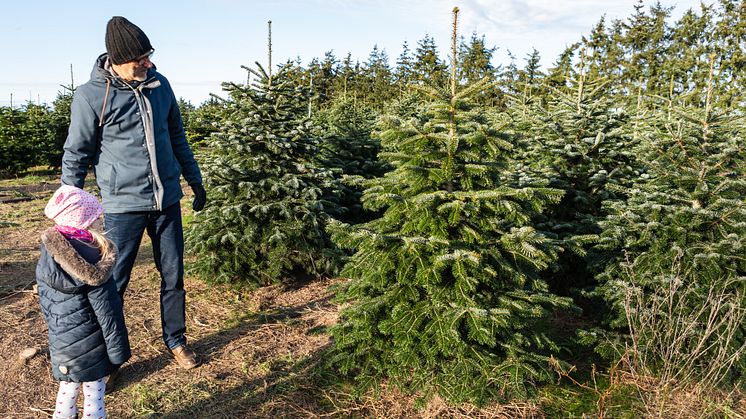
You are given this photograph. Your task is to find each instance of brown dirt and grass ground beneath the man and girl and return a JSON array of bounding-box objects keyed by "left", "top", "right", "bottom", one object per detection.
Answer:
[{"left": 0, "top": 175, "right": 541, "bottom": 418}]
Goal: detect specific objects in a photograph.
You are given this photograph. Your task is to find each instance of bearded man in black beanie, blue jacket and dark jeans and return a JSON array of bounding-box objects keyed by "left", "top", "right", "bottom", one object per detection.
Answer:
[{"left": 62, "top": 16, "right": 206, "bottom": 369}]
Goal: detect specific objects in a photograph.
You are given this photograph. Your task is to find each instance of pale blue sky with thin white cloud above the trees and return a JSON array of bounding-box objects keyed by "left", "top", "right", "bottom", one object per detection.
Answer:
[{"left": 0, "top": 0, "right": 712, "bottom": 106}]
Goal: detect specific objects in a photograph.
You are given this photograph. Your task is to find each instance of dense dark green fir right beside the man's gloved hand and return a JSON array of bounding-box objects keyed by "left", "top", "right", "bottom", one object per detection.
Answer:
[{"left": 187, "top": 63, "right": 338, "bottom": 285}]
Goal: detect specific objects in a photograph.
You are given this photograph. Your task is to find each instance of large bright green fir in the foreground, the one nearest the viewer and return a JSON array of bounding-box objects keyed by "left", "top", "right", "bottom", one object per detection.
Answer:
[{"left": 330, "top": 9, "right": 571, "bottom": 402}]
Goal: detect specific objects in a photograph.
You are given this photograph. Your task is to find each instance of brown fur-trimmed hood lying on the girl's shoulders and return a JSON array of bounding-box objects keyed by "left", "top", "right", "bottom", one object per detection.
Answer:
[{"left": 41, "top": 227, "right": 117, "bottom": 286}]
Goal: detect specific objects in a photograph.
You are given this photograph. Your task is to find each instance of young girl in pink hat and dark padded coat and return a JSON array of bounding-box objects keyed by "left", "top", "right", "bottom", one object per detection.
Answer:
[{"left": 36, "top": 185, "right": 130, "bottom": 419}]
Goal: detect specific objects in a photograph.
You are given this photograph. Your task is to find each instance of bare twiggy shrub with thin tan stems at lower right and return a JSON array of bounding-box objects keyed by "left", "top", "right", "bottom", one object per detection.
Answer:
[{"left": 623, "top": 249, "right": 746, "bottom": 417}]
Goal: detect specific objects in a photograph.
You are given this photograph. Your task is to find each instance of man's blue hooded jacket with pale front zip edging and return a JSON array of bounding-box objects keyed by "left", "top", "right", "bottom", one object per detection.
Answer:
[{"left": 62, "top": 54, "right": 202, "bottom": 213}]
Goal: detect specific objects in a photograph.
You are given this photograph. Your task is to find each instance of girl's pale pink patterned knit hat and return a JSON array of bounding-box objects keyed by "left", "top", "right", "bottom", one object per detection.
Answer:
[{"left": 44, "top": 185, "right": 104, "bottom": 229}]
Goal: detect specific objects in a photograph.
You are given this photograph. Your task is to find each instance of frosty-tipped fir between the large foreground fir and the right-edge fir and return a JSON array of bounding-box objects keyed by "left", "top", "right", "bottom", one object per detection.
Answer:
[{"left": 514, "top": 51, "right": 639, "bottom": 296}]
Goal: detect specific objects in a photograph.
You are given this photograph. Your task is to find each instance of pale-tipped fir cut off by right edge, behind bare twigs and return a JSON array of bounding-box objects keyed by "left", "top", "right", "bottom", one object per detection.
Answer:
[{"left": 599, "top": 57, "right": 746, "bottom": 385}]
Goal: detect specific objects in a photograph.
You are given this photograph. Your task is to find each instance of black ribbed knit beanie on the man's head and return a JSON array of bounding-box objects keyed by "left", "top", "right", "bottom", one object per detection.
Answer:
[{"left": 106, "top": 16, "right": 153, "bottom": 64}]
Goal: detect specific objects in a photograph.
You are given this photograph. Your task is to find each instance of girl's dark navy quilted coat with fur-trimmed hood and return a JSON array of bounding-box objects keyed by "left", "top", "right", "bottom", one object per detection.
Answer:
[{"left": 36, "top": 228, "right": 131, "bottom": 382}]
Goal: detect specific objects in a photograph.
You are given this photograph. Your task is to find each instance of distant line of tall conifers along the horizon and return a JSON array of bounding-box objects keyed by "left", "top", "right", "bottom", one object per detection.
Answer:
[{"left": 0, "top": 0, "right": 746, "bottom": 176}]
